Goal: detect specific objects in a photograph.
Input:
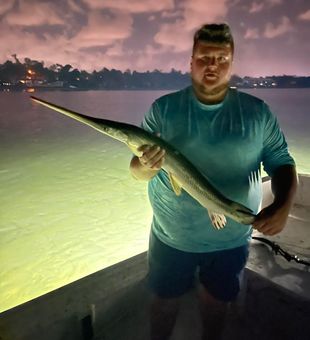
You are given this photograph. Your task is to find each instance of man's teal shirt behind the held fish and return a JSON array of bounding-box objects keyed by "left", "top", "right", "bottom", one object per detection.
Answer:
[{"left": 142, "top": 86, "right": 295, "bottom": 252}]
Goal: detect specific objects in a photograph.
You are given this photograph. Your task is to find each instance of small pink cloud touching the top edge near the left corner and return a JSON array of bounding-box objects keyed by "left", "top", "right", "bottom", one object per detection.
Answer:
[{"left": 5, "top": 0, "right": 64, "bottom": 26}]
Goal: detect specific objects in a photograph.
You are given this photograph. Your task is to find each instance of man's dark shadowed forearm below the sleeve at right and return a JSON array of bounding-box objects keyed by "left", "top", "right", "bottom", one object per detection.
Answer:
[{"left": 271, "top": 165, "right": 298, "bottom": 209}]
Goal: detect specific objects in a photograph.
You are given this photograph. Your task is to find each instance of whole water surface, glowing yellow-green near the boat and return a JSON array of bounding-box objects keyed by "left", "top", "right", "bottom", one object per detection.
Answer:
[{"left": 0, "top": 89, "right": 310, "bottom": 312}]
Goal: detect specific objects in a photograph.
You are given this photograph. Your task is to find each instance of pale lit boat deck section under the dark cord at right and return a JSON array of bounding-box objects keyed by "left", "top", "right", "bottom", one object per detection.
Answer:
[{"left": 247, "top": 205, "right": 310, "bottom": 300}]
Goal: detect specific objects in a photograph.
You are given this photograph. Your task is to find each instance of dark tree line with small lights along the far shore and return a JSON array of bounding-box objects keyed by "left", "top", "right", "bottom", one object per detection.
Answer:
[{"left": 0, "top": 55, "right": 310, "bottom": 90}]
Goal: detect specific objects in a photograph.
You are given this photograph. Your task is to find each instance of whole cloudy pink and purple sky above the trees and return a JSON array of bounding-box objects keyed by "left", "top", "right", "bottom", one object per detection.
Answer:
[{"left": 0, "top": 0, "right": 310, "bottom": 76}]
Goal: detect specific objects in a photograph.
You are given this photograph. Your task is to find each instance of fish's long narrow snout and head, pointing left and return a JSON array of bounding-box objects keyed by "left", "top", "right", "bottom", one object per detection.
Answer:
[{"left": 30, "top": 96, "right": 128, "bottom": 143}]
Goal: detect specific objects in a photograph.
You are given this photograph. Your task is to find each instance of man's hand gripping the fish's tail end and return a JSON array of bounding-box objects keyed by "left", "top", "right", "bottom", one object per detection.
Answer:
[{"left": 253, "top": 203, "right": 290, "bottom": 236}]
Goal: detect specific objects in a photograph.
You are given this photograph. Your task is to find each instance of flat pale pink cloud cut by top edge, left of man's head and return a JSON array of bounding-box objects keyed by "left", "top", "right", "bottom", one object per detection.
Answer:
[{"left": 85, "top": 0, "right": 174, "bottom": 13}]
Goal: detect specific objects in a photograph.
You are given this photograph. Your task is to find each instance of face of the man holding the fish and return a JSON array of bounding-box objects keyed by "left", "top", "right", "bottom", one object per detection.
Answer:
[{"left": 191, "top": 41, "right": 232, "bottom": 92}]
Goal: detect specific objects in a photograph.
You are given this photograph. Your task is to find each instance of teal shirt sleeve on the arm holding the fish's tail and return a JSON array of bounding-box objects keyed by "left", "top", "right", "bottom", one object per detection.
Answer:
[{"left": 262, "top": 103, "right": 295, "bottom": 176}]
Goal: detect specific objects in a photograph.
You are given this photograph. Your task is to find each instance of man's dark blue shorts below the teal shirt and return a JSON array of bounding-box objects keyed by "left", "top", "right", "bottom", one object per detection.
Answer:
[{"left": 148, "top": 232, "right": 249, "bottom": 302}]
